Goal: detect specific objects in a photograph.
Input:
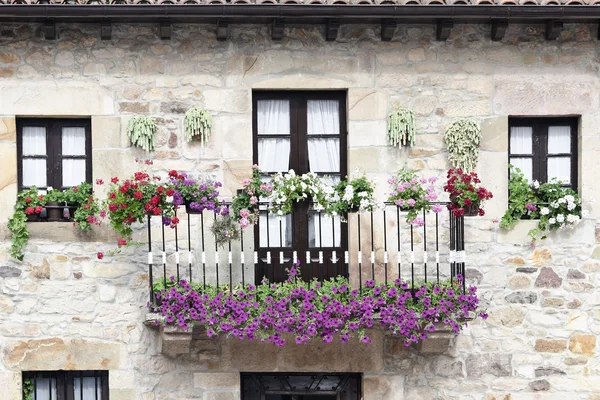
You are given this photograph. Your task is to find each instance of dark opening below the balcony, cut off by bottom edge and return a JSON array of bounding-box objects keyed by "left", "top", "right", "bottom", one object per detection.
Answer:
[{"left": 241, "top": 372, "right": 362, "bottom": 400}]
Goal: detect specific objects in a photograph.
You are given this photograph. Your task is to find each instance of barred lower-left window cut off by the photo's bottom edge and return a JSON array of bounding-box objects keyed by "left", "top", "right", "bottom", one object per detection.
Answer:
[{"left": 23, "top": 371, "right": 108, "bottom": 400}]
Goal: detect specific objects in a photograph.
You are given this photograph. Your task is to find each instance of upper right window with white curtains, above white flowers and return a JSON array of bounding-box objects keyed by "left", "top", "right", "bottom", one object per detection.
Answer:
[{"left": 509, "top": 118, "right": 578, "bottom": 190}]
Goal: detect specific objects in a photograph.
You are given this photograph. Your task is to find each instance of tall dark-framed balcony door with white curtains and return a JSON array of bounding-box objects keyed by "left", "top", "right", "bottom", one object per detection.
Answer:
[{"left": 253, "top": 91, "right": 348, "bottom": 282}]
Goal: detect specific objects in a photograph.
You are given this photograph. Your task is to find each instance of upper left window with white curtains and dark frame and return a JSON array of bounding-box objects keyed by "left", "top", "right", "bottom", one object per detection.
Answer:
[{"left": 17, "top": 118, "right": 92, "bottom": 190}]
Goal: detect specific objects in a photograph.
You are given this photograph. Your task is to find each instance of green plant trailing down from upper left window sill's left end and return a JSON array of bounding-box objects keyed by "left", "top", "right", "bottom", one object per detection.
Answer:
[{"left": 8, "top": 186, "right": 46, "bottom": 261}]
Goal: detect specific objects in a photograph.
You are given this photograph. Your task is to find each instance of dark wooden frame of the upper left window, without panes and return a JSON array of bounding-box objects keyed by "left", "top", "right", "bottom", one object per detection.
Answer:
[{"left": 17, "top": 118, "right": 92, "bottom": 190}]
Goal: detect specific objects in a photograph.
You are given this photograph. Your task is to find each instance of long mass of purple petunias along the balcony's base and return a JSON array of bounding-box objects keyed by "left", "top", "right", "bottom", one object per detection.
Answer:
[{"left": 153, "top": 268, "right": 487, "bottom": 346}]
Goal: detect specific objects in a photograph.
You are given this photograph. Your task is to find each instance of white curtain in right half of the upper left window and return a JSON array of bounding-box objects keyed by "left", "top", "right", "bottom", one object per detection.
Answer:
[{"left": 62, "top": 127, "right": 86, "bottom": 187}]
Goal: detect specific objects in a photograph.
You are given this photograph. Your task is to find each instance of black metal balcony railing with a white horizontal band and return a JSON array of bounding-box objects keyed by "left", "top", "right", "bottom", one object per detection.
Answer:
[{"left": 147, "top": 204, "right": 466, "bottom": 303}]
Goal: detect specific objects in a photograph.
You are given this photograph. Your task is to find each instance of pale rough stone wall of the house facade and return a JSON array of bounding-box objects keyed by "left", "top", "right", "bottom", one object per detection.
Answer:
[{"left": 0, "top": 24, "right": 600, "bottom": 400}]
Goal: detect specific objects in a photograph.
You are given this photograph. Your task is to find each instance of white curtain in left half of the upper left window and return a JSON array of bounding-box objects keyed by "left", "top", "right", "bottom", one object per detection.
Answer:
[{"left": 22, "top": 126, "right": 46, "bottom": 187}]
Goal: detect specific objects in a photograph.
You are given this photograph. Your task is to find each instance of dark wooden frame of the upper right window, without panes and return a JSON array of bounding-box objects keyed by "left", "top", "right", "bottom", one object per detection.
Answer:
[{"left": 508, "top": 117, "right": 579, "bottom": 191}]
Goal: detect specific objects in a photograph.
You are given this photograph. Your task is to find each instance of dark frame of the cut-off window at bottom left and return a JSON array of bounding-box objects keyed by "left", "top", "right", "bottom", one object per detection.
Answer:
[{"left": 23, "top": 370, "right": 109, "bottom": 400}]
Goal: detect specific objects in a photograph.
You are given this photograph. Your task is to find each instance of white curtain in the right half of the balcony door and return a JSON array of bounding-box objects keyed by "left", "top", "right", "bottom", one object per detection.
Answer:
[{"left": 307, "top": 100, "right": 341, "bottom": 247}]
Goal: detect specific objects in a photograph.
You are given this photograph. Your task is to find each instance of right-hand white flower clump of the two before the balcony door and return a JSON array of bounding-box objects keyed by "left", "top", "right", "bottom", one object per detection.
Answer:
[{"left": 323, "top": 171, "right": 376, "bottom": 216}]
